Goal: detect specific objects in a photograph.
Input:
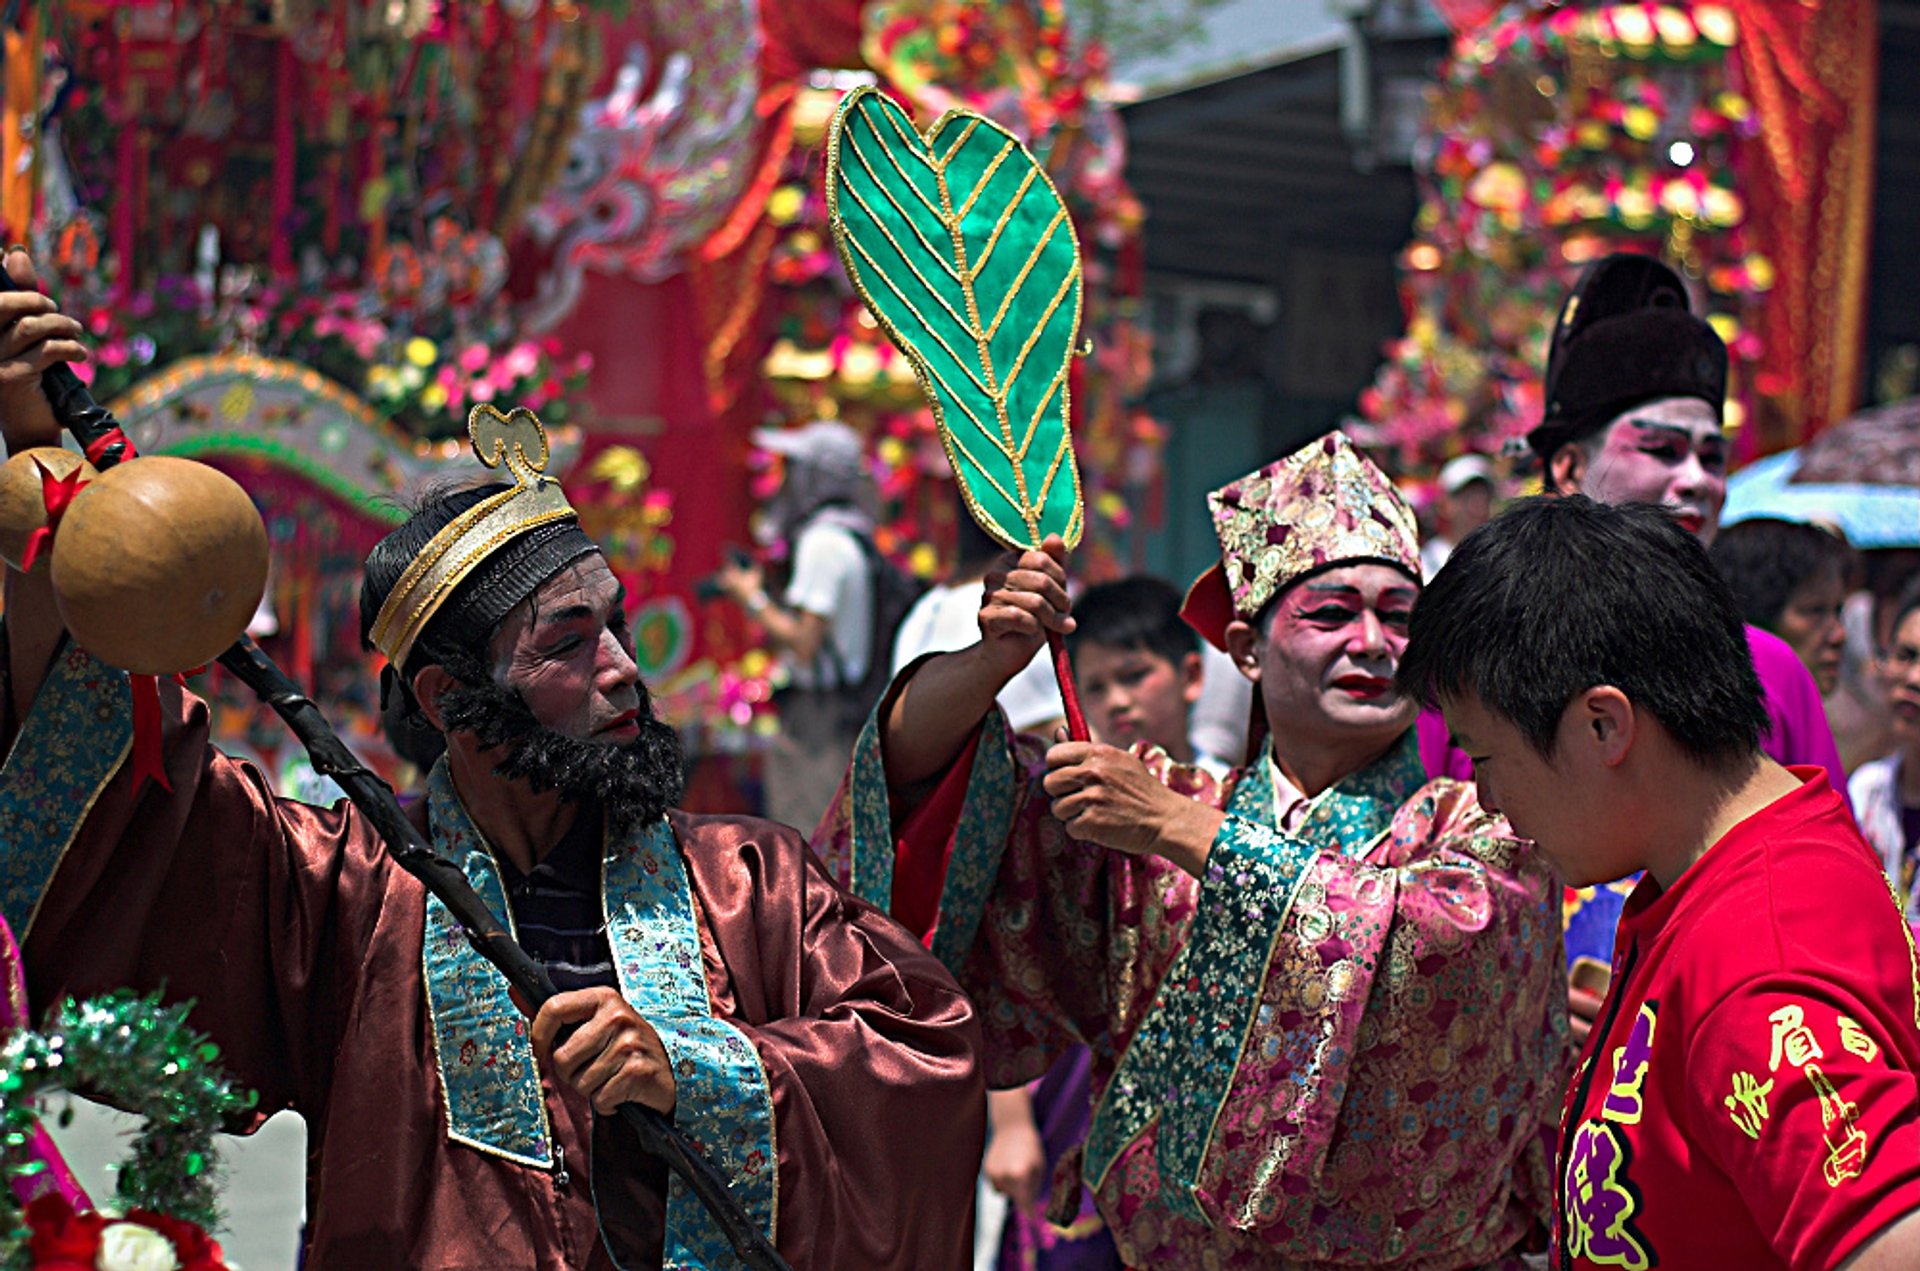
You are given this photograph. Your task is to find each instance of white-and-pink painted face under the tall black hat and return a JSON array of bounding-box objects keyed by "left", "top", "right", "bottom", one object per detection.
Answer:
[{"left": 1580, "top": 397, "right": 1726, "bottom": 543}]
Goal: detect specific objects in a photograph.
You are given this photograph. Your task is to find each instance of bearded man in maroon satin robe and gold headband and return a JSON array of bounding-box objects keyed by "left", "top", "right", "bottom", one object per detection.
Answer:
[{"left": 0, "top": 255, "right": 983, "bottom": 1271}]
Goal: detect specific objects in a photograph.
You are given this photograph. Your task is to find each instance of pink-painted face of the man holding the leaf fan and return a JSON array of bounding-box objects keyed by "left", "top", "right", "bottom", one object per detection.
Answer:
[{"left": 1242, "top": 564, "right": 1419, "bottom": 745}]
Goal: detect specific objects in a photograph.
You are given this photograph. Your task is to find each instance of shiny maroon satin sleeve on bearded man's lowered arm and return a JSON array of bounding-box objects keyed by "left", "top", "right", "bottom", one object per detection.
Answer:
[{"left": 674, "top": 816, "right": 985, "bottom": 1271}]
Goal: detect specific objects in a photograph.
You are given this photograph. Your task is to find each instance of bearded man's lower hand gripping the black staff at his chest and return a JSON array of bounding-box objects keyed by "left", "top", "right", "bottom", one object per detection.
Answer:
[{"left": 532, "top": 989, "right": 676, "bottom": 1115}]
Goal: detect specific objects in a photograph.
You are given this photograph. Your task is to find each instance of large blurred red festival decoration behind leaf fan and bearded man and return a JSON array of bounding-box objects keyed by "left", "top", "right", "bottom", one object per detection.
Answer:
[{"left": 15, "top": 0, "right": 1160, "bottom": 749}]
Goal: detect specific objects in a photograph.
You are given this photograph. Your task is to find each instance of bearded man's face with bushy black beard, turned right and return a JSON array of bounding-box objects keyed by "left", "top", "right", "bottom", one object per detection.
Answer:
[{"left": 440, "top": 555, "right": 684, "bottom": 827}]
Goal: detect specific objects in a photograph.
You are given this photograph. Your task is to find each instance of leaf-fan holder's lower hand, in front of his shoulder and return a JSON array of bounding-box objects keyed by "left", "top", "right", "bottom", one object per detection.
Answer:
[{"left": 1043, "top": 730, "right": 1227, "bottom": 877}]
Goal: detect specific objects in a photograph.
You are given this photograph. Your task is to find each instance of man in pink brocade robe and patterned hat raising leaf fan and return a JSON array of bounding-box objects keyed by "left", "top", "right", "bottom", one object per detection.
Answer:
[{"left": 822, "top": 436, "right": 1571, "bottom": 1271}]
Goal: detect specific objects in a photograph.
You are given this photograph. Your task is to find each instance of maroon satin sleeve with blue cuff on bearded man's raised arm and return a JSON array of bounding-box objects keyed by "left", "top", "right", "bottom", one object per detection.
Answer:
[{"left": 0, "top": 647, "right": 394, "bottom": 1119}]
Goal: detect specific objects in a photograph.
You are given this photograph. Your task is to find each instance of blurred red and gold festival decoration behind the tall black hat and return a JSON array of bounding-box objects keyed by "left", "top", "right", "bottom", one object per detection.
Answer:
[{"left": 1359, "top": 0, "right": 1876, "bottom": 472}]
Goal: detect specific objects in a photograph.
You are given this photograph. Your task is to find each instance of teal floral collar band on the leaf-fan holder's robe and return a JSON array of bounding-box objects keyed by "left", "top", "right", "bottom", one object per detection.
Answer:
[{"left": 1081, "top": 728, "right": 1427, "bottom": 1223}]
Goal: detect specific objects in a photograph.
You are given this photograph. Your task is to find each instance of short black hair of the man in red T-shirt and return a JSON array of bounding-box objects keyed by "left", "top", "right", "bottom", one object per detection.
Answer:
[{"left": 1394, "top": 495, "right": 1766, "bottom": 766}]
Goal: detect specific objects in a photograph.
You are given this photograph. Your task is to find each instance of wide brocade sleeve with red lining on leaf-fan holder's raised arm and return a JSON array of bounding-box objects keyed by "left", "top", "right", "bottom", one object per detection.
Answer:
[{"left": 814, "top": 699, "right": 1227, "bottom": 1089}]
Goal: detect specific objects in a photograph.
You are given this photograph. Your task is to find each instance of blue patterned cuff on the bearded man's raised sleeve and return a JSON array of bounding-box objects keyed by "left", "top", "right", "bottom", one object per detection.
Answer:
[{"left": 0, "top": 641, "right": 132, "bottom": 945}]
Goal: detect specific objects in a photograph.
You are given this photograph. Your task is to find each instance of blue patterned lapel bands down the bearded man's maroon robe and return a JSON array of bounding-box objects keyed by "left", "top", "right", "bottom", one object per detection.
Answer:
[{"left": 422, "top": 760, "right": 778, "bottom": 1267}]
